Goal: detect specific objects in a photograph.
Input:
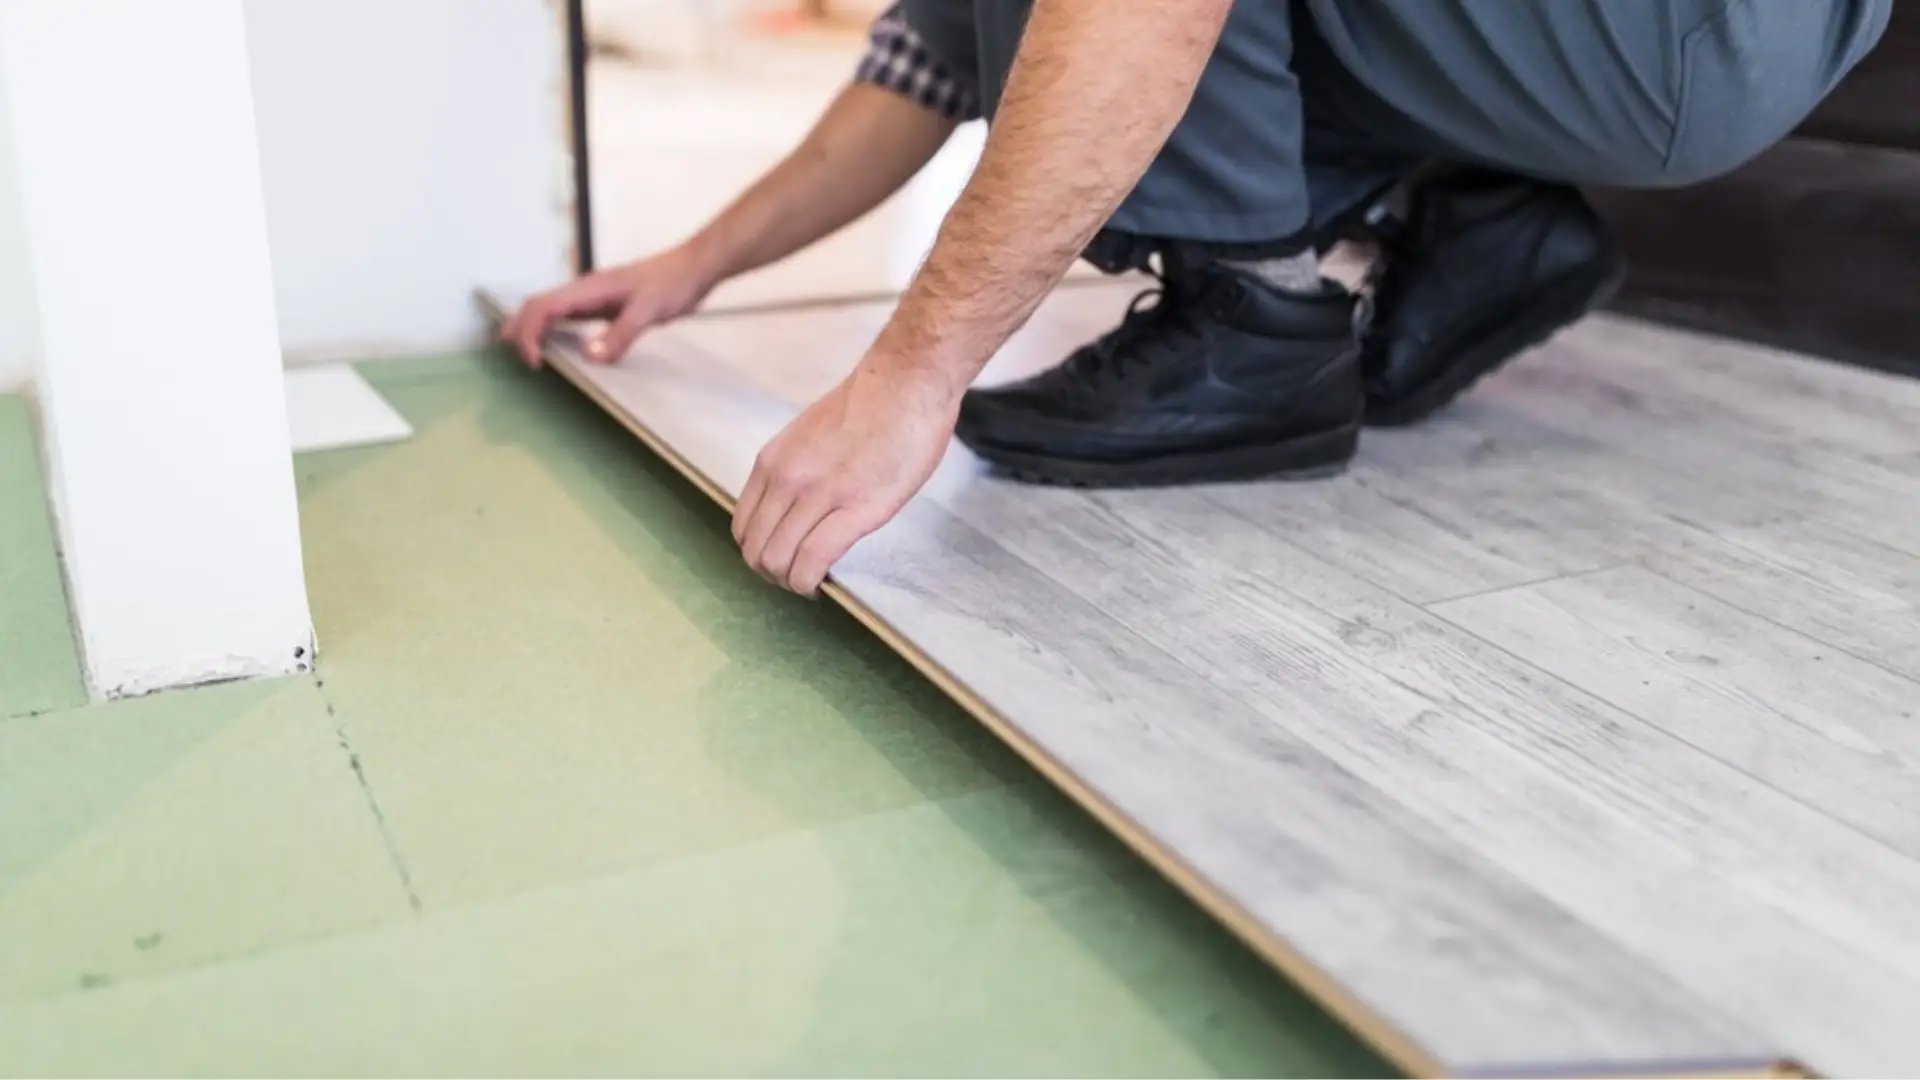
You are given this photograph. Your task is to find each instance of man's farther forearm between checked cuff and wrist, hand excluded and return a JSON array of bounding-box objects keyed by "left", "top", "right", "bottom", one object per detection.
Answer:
[{"left": 687, "top": 83, "right": 956, "bottom": 281}]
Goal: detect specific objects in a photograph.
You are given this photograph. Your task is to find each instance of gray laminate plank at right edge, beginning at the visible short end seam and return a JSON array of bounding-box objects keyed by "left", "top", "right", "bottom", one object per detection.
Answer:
[{"left": 1432, "top": 567, "right": 1920, "bottom": 857}]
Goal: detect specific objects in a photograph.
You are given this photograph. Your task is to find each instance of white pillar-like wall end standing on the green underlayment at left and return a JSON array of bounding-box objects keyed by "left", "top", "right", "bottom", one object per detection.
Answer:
[{"left": 0, "top": 0, "right": 313, "bottom": 696}]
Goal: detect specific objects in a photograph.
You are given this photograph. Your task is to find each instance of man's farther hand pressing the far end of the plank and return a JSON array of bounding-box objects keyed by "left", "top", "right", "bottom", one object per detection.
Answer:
[{"left": 499, "top": 248, "right": 718, "bottom": 367}]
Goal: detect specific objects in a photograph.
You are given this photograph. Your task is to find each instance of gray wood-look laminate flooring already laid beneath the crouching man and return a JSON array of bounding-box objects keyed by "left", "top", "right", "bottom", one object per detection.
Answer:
[{"left": 483, "top": 284, "right": 1920, "bottom": 1074}]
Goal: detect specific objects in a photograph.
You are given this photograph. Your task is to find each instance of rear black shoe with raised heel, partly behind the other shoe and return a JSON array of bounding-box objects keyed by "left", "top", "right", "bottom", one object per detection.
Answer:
[{"left": 1361, "top": 171, "right": 1624, "bottom": 427}]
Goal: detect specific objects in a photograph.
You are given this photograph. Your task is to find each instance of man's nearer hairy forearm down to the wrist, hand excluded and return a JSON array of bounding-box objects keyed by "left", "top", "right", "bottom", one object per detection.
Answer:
[{"left": 870, "top": 0, "right": 1231, "bottom": 394}]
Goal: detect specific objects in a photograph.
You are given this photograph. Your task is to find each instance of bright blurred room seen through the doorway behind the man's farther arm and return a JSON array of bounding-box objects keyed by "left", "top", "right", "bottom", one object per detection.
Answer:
[{"left": 586, "top": 0, "right": 985, "bottom": 309}]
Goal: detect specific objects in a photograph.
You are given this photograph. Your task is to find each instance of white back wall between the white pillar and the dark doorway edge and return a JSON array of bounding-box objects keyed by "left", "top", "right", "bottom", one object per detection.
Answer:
[{"left": 243, "top": 0, "right": 572, "bottom": 361}]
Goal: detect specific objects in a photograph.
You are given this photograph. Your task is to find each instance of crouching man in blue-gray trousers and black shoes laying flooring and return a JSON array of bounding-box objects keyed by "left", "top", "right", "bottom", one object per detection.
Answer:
[{"left": 505, "top": 0, "right": 1891, "bottom": 594}]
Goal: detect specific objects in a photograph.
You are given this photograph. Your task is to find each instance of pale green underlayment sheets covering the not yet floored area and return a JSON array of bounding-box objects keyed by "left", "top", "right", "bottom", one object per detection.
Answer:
[{"left": 0, "top": 357, "right": 1386, "bottom": 1076}]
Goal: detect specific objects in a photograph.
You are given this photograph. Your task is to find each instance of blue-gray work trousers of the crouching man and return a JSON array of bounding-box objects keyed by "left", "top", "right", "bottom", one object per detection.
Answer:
[{"left": 904, "top": 0, "right": 1889, "bottom": 254}]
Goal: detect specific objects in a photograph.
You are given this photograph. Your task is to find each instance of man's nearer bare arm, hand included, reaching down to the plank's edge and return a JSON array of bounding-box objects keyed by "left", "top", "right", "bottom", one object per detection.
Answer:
[{"left": 733, "top": 0, "right": 1233, "bottom": 596}]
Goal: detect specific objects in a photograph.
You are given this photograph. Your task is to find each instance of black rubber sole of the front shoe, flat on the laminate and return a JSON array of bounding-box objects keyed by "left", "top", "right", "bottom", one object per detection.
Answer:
[{"left": 972, "top": 423, "right": 1361, "bottom": 488}]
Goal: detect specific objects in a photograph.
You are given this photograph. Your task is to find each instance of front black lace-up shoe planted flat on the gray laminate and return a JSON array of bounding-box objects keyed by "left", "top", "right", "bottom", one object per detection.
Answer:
[{"left": 954, "top": 261, "right": 1363, "bottom": 486}]
